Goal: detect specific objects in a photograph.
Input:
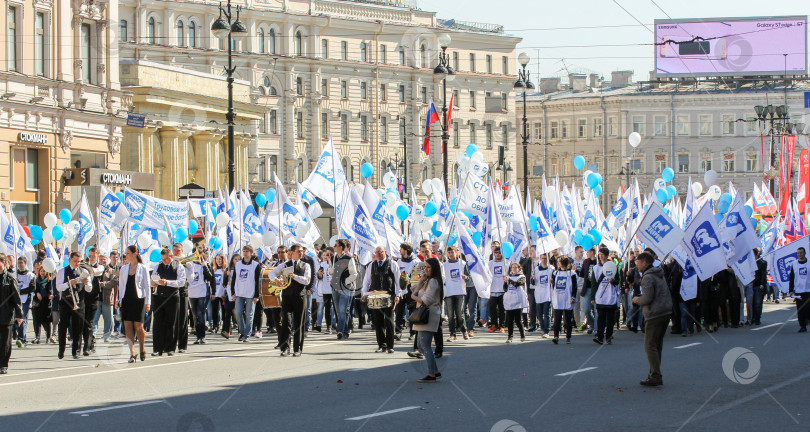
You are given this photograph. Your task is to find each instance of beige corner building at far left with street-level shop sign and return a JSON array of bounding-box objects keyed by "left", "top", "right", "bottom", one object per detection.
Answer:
[{"left": 0, "top": 0, "right": 130, "bottom": 224}]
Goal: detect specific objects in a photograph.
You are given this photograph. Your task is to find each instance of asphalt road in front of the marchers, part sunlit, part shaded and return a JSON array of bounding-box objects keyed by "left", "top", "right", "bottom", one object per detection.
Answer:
[{"left": 0, "top": 303, "right": 810, "bottom": 432}]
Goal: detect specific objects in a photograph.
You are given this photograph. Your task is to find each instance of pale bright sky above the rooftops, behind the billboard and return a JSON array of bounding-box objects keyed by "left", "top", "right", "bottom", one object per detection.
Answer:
[{"left": 426, "top": 0, "right": 810, "bottom": 81}]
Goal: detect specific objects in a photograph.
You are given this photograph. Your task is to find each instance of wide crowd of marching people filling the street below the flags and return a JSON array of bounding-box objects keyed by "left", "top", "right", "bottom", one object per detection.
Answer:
[{"left": 0, "top": 239, "right": 810, "bottom": 386}]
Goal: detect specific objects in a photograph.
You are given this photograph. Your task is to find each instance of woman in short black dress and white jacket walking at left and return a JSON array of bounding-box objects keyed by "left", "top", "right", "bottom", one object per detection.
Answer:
[{"left": 115, "top": 245, "right": 152, "bottom": 363}]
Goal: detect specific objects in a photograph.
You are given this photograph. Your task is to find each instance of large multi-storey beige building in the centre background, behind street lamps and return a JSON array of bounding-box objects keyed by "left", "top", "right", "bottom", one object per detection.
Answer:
[{"left": 116, "top": 0, "right": 520, "bottom": 213}]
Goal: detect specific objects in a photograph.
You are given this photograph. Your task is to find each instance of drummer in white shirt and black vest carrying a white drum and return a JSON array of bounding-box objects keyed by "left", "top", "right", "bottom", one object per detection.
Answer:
[{"left": 362, "top": 246, "right": 402, "bottom": 354}]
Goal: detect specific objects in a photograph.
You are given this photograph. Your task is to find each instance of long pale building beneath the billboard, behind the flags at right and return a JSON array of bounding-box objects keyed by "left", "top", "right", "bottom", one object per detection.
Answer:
[{"left": 517, "top": 71, "right": 810, "bottom": 207}]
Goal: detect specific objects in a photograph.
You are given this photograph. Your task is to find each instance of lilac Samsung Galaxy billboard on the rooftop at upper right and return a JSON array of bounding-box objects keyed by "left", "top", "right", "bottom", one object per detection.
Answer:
[{"left": 655, "top": 15, "right": 807, "bottom": 78}]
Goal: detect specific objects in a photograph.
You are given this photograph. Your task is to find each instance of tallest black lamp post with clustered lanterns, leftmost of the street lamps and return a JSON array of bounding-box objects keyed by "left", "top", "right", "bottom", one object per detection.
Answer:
[{"left": 211, "top": 0, "right": 248, "bottom": 190}]
